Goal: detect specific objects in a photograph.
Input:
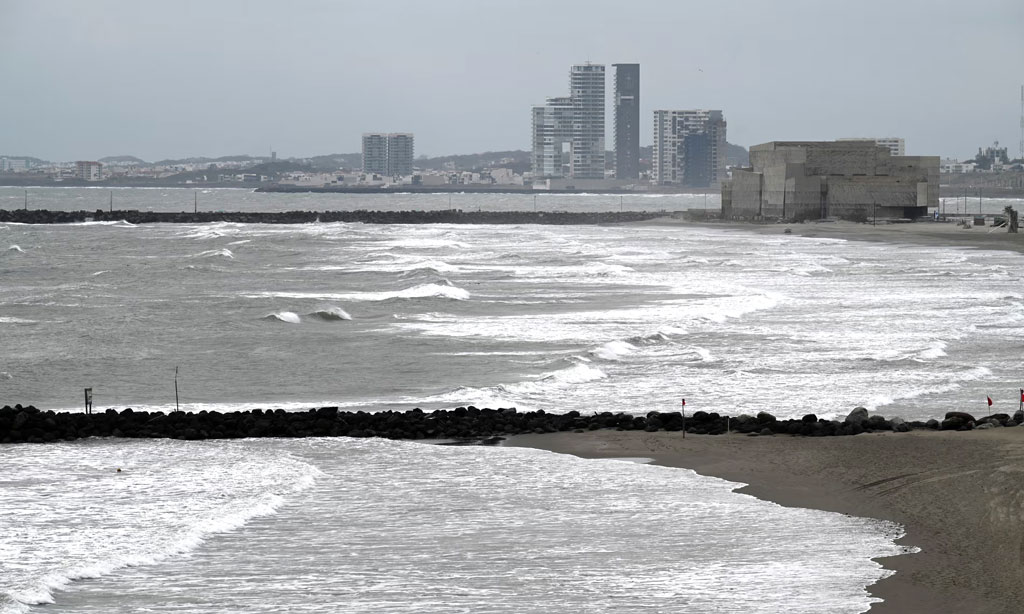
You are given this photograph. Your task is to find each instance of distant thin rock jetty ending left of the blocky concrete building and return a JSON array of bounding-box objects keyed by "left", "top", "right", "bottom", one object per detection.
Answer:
[{"left": 0, "top": 209, "right": 669, "bottom": 225}]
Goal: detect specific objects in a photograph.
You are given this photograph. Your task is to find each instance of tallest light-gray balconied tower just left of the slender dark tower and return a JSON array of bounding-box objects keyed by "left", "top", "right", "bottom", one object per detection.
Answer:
[{"left": 569, "top": 62, "right": 604, "bottom": 179}]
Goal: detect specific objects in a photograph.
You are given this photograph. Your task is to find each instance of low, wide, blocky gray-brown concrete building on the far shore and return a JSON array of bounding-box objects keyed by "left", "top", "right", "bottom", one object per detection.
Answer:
[{"left": 722, "top": 141, "right": 939, "bottom": 219}]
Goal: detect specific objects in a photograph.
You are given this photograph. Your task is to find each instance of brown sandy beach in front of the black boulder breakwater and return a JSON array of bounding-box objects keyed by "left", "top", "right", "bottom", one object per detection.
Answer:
[{"left": 509, "top": 427, "right": 1024, "bottom": 614}]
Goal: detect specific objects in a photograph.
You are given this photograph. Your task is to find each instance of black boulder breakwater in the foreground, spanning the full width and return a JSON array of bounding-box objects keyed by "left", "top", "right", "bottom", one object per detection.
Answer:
[{"left": 0, "top": 405, "right": 1024, "bottom": 443}]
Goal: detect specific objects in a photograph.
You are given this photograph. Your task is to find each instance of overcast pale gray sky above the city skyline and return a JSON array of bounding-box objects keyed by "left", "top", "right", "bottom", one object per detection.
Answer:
[{"left": 0, "top": 0, "right": 1024, "bottom": 161}]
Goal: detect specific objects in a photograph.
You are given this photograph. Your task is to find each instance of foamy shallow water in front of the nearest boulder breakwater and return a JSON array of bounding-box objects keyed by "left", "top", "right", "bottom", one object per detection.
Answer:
[{"left": 0, "top": 438, "right": 902, "bottom": 614}]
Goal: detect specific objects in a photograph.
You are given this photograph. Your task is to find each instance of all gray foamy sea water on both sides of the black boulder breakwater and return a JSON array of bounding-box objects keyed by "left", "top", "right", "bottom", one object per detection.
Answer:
[{"left": 0, "top": 188, "right": 1024, "bottom": 614}]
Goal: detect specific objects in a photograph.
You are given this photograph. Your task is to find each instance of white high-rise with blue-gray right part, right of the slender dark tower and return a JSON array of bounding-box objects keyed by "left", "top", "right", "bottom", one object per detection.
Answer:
[{"left": 651, "top": 108, "right": 726, "bottom": 187}]
